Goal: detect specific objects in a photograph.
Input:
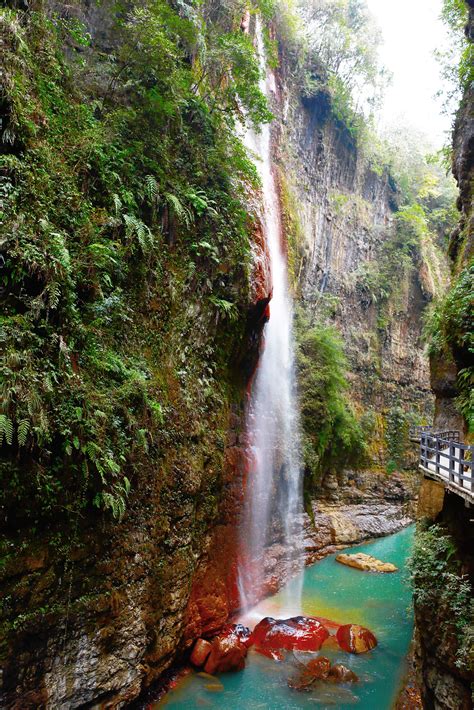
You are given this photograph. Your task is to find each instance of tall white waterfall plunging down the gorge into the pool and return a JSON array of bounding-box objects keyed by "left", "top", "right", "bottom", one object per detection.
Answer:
[{"left": 239, "top": 18, "right": 302, "bottom": 608}]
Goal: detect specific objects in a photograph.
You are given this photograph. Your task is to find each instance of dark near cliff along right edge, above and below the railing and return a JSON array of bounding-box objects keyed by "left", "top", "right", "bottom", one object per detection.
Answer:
[{"left": 414, "top": 2, "right": 474, "bottom": 710}]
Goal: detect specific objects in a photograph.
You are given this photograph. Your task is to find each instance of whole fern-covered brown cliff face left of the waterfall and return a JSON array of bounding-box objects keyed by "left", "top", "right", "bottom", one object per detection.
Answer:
[{"left": 0, "top": 2, "right": 268, "bottom": 710}]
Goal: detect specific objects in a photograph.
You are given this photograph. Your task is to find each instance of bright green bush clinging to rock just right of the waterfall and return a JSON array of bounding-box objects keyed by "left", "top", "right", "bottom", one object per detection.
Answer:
[{"left": 297, "top": 316, "right": 366, "bottom": 489}]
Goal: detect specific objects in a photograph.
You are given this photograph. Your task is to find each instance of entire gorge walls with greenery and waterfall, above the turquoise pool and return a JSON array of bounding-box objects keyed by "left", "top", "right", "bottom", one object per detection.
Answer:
[{"left": 0, "top": 0, "right": 474, "bottom": 710}]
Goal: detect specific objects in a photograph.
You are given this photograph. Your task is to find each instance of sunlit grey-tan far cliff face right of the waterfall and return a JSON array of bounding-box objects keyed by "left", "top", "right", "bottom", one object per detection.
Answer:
[{"left": 279, "top": 72, "right": 444, "bottom": 466}]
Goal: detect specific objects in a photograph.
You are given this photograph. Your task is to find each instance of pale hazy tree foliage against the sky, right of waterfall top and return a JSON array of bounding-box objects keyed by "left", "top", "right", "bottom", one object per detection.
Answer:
[{"left": 274, "top": 0, "right": 388, "bottom": 141}]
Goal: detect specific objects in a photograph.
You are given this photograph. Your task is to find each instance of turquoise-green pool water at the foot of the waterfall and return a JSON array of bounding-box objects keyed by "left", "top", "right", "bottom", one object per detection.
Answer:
[{"left": 159, "top": 528, "right": 413, "bottom": 710}]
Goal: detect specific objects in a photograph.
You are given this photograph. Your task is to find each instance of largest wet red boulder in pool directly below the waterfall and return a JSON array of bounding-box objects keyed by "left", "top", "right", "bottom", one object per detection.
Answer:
[{"left": 251, "top": 616, "right": 329, "bottom": 651}]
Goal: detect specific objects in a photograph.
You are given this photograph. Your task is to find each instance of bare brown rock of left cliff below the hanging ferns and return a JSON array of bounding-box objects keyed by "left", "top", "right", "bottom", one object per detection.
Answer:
[{"left": 0, "top": 0, "right": 269, "bottom": 710}]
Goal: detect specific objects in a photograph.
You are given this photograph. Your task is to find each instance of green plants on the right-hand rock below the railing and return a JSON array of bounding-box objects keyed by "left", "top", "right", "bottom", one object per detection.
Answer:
[{"left": 410, "top": 524, "right": 474, "bottom": 671}]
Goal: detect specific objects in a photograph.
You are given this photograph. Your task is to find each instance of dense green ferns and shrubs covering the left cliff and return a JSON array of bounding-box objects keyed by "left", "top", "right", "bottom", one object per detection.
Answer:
[{"left": 0, "top": 0, "right": 270, "bottom": 518}]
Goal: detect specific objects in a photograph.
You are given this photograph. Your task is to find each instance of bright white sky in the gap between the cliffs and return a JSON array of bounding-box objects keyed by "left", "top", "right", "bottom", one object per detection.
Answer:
[{"left": 367, "top": 0, "right": 451, "bottom": 149}]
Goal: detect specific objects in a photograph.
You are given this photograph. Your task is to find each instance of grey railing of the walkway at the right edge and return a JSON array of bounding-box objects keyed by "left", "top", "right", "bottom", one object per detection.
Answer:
[{"left": 420, "top": 430, "right": 474, "bottom": 501}]
